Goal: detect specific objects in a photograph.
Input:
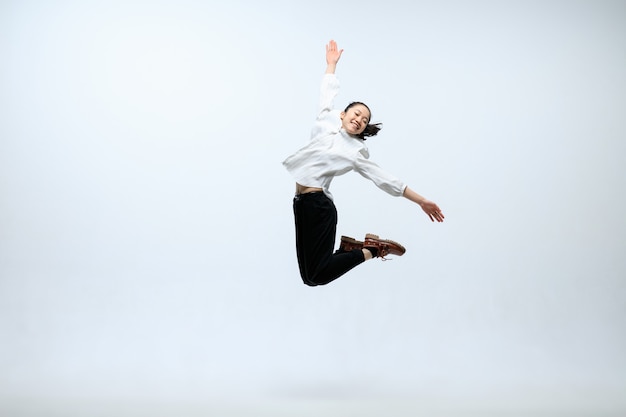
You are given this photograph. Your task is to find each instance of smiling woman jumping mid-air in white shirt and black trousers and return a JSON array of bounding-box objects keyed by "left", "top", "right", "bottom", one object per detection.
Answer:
[{"left": 283, "top": 40, "right": 444, "bottom": 286}]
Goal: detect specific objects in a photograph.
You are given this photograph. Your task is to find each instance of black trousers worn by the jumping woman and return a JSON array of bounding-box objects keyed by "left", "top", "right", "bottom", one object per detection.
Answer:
[{"left": 293, "top": 192, "right": 365, "bottom": 286}]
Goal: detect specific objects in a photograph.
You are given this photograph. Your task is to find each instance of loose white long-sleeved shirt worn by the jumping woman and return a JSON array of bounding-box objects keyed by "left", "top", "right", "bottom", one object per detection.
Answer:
[{"left": 283, "top": 74, "right": 406, "bottom": 200}]
